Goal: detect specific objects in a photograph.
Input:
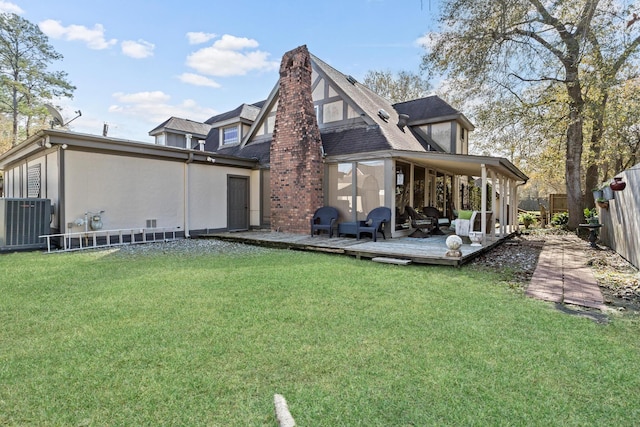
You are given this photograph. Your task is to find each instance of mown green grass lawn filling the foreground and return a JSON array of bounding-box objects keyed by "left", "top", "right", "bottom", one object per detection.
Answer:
[{"left": 0, "top": 246, "right": 640, "bottom": 426}]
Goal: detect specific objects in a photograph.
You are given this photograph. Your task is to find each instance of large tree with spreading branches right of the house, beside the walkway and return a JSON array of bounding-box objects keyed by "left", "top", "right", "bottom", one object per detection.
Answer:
[{"left": 423, "top": 0, "right": 640, "bottom": 228}]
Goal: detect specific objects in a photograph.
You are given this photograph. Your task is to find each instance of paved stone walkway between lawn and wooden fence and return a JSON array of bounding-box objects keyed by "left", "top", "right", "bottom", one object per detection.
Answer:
[{"left": 526, "top": 236, "right": 604, "bottom": 310}]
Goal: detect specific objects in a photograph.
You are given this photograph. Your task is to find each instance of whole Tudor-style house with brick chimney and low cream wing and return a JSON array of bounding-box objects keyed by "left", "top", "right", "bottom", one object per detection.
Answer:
[{"left": 0, "top": 46, "right": 528, "bottom": 244}]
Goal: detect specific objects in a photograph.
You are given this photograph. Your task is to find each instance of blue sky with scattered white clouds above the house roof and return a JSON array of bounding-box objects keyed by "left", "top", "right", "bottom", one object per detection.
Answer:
[{"left": 0, "top": 0, "right": 438, "bottom": 142}]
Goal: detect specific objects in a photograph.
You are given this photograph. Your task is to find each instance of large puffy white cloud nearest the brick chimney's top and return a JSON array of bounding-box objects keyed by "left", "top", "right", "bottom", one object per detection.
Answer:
[{"left": 187, "top": 34, "right": 279, "bottom": 76}]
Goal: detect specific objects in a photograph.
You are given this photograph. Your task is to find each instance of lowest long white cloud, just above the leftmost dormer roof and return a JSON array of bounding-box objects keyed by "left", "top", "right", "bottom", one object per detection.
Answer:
[{"left": 109, "top": 91, "right": 217, "bottom": 123}]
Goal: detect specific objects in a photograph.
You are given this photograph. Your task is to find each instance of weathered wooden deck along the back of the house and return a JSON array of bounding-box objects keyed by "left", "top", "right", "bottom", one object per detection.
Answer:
[{"left": 199, "top": 231, "right": 508, "bottom": 266}]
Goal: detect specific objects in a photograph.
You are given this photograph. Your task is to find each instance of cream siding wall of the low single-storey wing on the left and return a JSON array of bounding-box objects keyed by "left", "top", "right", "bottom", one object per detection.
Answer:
[{"left": 2, "top": 131, "right": 260, "bottom": 241}]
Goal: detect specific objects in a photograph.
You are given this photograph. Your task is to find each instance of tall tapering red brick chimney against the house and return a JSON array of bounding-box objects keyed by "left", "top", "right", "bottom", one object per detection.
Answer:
[{"left": 270, "top": 45, "right": 324, "bottom": 234}]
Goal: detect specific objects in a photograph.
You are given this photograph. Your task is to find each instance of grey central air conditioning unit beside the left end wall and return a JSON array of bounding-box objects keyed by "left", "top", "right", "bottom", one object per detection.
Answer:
[{"left": 0, "top": 198, "right": 51, "bottom": 251}]
